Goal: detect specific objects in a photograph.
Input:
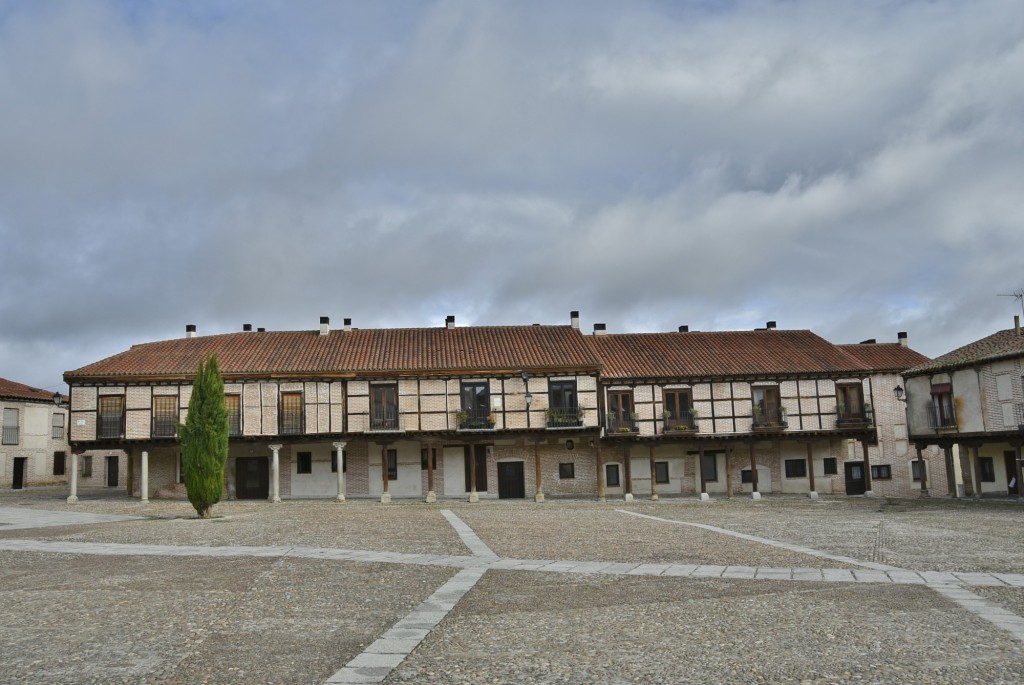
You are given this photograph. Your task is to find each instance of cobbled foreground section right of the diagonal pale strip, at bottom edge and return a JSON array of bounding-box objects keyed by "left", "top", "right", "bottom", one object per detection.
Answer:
[{"left": 385, "top": 571, "right": 1024, "bottom": 685}]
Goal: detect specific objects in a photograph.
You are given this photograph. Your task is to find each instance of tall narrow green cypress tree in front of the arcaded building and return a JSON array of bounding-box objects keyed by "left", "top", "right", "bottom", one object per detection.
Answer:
[{"left": 178, "top": 354, "right": 227, "bottom": 518}]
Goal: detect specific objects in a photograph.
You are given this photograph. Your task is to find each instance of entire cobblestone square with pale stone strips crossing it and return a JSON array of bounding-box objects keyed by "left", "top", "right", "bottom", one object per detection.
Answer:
[{"left": 0, "top": 490, "right": 1024, "bottom": 685}]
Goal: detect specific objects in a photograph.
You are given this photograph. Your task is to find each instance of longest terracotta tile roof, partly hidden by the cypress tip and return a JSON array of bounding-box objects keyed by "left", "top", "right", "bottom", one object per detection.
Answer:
[{"left": 65, "top": 326, "right": 599, "bottom": 382}]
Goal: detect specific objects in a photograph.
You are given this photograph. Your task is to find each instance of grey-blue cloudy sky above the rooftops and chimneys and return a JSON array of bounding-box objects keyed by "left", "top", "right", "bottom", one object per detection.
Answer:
[{"left": 0, "top": 0, "right": 1024, "bottom": 389}]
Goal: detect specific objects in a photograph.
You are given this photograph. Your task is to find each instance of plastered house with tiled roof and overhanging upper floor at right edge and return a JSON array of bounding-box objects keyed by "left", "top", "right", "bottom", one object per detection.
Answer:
[{"left": 900, "top": 316, "right": 1024, "bottom": 498}]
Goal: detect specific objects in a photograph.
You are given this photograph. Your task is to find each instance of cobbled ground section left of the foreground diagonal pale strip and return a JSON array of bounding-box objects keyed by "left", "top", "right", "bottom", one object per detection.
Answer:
[{"left": 0, "top": 553, "right": 453, "bottom": 685}]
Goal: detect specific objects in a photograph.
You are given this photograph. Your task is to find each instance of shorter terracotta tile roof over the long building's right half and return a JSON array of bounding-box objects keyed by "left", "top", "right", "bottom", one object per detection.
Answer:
[{"left": 586, "top": 330, "right": 868, "bottom": 379}]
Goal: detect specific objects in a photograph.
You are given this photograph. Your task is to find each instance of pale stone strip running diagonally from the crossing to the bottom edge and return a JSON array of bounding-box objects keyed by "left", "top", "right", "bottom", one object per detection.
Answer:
[{"left": 327, "top": 568, "right": 486, "bottom": 685}]
